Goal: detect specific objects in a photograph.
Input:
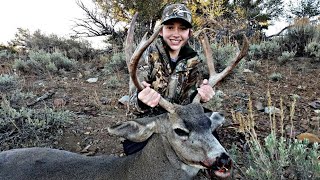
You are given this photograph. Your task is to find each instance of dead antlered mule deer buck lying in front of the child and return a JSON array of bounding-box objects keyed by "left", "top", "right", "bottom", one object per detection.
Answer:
[{"left": 0, "top": 13, "right": 248, "bottom": 180}]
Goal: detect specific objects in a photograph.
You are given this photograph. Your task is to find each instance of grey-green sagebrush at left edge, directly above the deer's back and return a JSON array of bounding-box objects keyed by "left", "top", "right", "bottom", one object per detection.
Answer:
[{"left": 0, "top": 97, "right": 73, "bottom": 151}]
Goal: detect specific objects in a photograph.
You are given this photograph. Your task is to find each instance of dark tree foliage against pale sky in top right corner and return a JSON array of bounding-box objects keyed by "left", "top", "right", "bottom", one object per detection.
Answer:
[{"left": 288, "top": 0, "right": 320, "bottom": 18}]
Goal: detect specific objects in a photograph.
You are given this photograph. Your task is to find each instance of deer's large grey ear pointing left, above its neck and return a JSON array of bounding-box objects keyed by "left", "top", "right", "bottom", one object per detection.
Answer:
[{"left": 108, "top": 121, "right": 156, "bottom": 142}]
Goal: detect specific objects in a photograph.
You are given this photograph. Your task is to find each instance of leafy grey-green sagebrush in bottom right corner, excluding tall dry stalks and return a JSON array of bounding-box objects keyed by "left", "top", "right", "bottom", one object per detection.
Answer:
[{"left": 230, "top": 134, "right": 320, "bottom": 180}]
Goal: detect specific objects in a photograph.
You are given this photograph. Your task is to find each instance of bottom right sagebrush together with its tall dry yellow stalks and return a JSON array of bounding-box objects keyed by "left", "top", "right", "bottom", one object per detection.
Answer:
[{"left": 229, "top": 95, "right": 320, "bottom": 180}]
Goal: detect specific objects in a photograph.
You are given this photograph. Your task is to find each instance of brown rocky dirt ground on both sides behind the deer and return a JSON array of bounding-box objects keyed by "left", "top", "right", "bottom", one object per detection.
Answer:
[{"left": 15, "top": 58, "right": 320, "bottom": 176}]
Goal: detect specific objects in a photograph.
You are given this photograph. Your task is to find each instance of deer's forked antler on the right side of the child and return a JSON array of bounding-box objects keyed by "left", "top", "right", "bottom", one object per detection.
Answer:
[{"left": 193, "top": 33, "right": 249, "bottom": 102}]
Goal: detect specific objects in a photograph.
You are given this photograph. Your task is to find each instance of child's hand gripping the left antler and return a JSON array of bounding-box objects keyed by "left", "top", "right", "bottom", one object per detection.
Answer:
[{"left": 138, "top": 81, "right": 161, "bottom": 107}]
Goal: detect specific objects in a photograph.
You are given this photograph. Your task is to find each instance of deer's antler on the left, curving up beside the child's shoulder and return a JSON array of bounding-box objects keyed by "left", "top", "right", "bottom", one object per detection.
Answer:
[{"left": 126, "top": 15, "right": 174, "bottom": 113}]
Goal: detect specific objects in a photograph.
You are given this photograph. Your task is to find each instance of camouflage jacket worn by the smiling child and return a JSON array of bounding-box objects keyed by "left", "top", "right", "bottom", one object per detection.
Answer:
[{"left": 130, "top": 38, "right": 203, "bottom": 114}]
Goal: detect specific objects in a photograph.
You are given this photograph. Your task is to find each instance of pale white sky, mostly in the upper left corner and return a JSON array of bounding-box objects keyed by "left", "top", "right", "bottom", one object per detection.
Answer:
[{"left": 0, "top": 0, "right": 285, "bottom": 48}]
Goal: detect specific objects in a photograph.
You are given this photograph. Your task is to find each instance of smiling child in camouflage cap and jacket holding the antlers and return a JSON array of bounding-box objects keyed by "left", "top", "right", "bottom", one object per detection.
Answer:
[{"left": 123, "top": 4, "right": 215, "bottom": 155}]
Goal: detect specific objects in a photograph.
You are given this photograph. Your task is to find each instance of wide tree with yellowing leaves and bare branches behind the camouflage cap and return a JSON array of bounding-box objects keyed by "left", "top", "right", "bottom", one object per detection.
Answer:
[{"left": 74, "top": 0, "right": 283, "bottom": 47}]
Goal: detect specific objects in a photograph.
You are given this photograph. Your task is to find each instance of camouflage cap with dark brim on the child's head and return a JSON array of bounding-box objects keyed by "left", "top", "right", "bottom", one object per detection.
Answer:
[{"left": 161, "top": 4, "right": 192, "bottom": 28}]
